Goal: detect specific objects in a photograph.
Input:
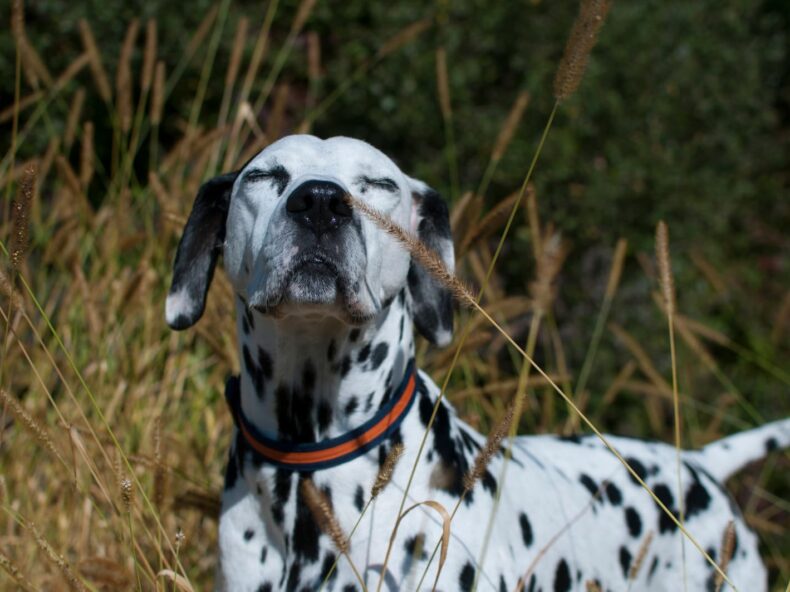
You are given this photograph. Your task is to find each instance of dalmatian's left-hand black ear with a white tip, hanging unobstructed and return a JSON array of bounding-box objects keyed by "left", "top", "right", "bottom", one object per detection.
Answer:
[{"left": 165, "top": 173, "right": 238, "bottom": 331}]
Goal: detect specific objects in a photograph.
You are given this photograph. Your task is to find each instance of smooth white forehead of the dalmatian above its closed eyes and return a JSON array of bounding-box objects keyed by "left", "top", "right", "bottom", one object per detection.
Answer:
[{"left": 245, "top": 135, "right": 403, "bottom": 181}]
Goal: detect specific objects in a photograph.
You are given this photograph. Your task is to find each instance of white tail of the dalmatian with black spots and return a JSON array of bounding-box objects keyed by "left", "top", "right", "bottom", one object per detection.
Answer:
[{"left": 689, "top": 418, "right": 790, "bottom": 481}]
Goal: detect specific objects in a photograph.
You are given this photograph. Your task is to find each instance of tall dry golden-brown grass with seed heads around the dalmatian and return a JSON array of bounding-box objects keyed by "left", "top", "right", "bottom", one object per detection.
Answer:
[{"left": 0, "top": 1, "right": 790, "bottom": 590}]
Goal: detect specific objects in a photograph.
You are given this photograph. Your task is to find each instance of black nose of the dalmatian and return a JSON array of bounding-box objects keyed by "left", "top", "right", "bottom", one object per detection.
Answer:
[{"left": 285, "top": 181, "right": 352, "bottom": 235}]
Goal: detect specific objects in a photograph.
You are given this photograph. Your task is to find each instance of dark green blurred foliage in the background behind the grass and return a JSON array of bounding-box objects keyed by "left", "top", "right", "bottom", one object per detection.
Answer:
[{"left": 0, "top": 0, "right": 790, "bottom": 588}]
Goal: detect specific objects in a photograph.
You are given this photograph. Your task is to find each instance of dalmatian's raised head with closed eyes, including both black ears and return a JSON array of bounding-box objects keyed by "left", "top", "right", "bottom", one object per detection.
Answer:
[{"left": 166, "top": 135, "right": 454, "bottom": 345}]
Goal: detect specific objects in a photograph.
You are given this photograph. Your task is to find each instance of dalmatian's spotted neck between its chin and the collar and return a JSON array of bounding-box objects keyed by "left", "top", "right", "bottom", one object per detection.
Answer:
[{"left": 237, "top": 290, "right": 414, "bottom": 442}]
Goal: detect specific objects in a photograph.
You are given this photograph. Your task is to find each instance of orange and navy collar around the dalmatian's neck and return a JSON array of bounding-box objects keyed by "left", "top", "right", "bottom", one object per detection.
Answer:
[{"left": 225, "top": 360, "right": 418, "bottom": 472}]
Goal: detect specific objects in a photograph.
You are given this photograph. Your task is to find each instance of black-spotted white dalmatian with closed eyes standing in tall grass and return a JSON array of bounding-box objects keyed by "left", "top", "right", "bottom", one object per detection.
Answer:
[{"left": 166, "top": 135, "right": 790, "bottom": 592}]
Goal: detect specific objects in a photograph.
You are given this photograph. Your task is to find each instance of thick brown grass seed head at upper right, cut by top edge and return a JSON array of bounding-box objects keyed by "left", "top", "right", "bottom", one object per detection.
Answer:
[{"left": 554, "top": 0, "right": 611, "bottom": 101}]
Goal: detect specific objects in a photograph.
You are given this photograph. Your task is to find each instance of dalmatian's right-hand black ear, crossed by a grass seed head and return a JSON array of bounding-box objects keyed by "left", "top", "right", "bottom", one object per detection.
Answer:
[{"left": 408, "top": 179, "right": 455, "bottom": 345}]
